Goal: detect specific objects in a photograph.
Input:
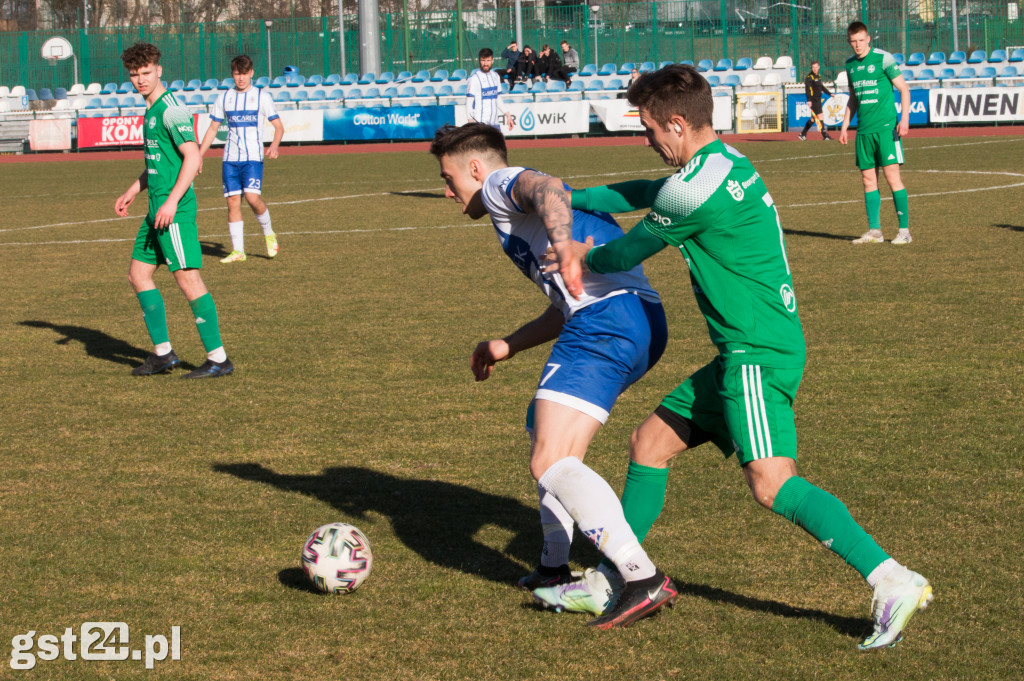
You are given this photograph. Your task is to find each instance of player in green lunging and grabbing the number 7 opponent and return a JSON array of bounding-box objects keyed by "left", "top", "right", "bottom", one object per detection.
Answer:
[{"left": 534, "top": 65, "right": 932, "bottom": 650}]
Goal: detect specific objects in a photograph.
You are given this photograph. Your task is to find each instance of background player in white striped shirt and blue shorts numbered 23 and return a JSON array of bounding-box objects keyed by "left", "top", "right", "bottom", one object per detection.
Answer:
[{"left": 199, "top": 54, "right": 285, "bottom": 262}]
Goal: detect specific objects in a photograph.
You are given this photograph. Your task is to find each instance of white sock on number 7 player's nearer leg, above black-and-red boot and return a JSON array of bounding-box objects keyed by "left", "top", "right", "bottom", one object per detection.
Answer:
[{"left": 538, "top": 457, "right": 656, "bottom": 582}]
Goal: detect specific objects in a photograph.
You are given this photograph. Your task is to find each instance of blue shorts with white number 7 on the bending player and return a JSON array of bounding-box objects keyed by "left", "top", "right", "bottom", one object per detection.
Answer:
[{"left": 526, "top": 293, "right": 669, "bottom": 430}]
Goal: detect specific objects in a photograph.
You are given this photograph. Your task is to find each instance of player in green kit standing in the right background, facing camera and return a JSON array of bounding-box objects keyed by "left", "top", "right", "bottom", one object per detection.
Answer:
[{"left": 839, "top": 22, "right": 913, "bottom": 246}]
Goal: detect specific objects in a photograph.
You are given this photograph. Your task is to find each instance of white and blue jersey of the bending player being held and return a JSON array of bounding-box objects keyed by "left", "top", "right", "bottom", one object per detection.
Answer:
[{"left": 481, "top": 168, "right": 660, "bottom": 321}]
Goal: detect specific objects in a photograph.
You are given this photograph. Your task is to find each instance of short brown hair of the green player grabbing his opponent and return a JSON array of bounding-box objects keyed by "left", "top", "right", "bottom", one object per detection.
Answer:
[{"left": 626, "top": 63, "right": 715, "bottom": 131}]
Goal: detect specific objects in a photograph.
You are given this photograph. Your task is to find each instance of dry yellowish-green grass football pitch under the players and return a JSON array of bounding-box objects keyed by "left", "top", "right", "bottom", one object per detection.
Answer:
[{"left": 0, "top": 137, "right": 1024, "bottom": 681}]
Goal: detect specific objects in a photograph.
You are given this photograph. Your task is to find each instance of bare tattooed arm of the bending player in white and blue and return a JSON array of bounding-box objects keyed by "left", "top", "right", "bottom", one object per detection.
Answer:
[{"left": 512, "top": 170, "right": 584, "bottom": 299}]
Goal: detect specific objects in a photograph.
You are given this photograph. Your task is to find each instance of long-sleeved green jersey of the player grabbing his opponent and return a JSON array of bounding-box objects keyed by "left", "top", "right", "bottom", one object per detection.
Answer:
[{"left": 572, "top": 139, "right": 806, "bottom": 368}]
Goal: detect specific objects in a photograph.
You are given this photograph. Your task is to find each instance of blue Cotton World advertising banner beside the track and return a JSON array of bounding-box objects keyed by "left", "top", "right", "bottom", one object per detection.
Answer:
[{"left": 323, "top": 107, "right": 461, "bottom": 140}]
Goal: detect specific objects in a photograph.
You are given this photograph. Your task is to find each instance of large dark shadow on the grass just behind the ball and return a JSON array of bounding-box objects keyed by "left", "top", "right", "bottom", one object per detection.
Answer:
[{"left": 213, "top": 464, "right": 541, "bottom": 586}]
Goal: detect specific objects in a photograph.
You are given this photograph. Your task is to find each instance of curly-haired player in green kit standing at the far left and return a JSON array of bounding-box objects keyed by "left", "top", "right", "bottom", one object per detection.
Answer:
[{"left": 114, "top": 43, "right": 234, "bottom": 378}]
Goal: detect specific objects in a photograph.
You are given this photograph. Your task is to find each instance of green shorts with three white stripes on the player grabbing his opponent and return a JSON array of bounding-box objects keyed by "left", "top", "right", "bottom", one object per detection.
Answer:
[{"left": 662, "top": 356, "right": 804, "bottom": 465}]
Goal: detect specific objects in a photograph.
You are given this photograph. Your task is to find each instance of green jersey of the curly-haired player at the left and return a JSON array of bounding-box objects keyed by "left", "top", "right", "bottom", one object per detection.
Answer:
[{"left": 142, "top": 91, "right": 196, "bottom": 216}]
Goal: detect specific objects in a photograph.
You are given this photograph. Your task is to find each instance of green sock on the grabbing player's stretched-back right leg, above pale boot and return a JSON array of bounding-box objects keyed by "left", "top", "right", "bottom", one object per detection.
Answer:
[{"left": 771, "top": 476, "right": 889, "bottom": 579}]
